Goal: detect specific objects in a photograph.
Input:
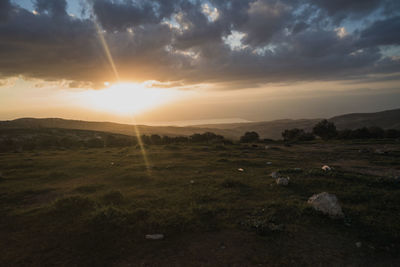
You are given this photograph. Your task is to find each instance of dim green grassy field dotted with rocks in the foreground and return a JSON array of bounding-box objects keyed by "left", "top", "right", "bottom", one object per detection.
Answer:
[{"left": 0, "top": 142, "right": 400, "bottom": 266}]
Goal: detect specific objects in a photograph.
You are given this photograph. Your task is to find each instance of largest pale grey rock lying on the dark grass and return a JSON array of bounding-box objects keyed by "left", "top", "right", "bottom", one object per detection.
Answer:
[{"left": 307, "top": 192, "right": 344, "bottom": 218}]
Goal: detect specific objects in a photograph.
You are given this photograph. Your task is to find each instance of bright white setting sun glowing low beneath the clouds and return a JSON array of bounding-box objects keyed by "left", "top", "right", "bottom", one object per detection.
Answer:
[{"left": 76, "top": 83, "right": 184, "bottom": 115}]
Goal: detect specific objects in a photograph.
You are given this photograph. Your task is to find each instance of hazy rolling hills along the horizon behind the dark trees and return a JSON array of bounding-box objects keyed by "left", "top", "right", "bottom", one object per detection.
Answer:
[{"left": 0, "top": 109, "right": 400, "bottom": 139}]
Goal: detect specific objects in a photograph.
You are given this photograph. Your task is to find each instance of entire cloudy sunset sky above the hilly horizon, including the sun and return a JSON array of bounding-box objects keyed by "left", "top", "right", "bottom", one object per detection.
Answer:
[{"left": 0, "top": 0, "right": 400, "bottom": 125}]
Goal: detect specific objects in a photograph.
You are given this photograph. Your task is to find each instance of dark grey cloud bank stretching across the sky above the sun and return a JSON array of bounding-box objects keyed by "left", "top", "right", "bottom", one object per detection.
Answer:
[{"left": 0, "top": 0, "right": 400, "bottom": 88}]
